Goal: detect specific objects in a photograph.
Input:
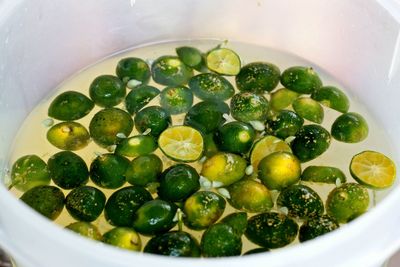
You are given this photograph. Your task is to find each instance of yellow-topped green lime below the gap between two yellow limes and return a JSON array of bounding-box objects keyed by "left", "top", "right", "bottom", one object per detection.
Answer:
[{"left": 227, "top": 179, "right": 274, "bottom": 212}]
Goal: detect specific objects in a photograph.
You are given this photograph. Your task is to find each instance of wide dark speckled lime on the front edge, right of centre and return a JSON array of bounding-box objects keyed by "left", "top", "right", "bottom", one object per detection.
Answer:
[{"left": 245, "top": 212, "right": 299, "bottom": 248}]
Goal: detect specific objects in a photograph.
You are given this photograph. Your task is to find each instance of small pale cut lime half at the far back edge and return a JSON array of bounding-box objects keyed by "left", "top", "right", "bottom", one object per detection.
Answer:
[{"left": 206, "top": 48, "right": 240, "bottom": 76}]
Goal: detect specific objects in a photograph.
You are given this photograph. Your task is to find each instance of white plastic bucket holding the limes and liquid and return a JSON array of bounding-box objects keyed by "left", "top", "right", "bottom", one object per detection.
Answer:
[{"left": 0, "top": 0, "right": 400, "bottom": 267}]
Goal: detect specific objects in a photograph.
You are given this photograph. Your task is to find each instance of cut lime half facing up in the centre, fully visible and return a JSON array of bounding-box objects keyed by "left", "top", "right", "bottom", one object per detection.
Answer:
[{"left": 158, "top": 126, "right": 204, "bottom": 162}]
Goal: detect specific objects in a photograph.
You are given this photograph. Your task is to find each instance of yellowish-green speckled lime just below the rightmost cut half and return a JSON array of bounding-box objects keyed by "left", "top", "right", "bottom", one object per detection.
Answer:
[{"left": 326, "top": 183, "right": 369, "bottom": 223}]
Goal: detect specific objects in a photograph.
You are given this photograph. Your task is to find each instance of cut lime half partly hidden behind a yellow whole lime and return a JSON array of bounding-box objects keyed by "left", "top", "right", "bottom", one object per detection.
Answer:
[{"left": 250, "top": 135, "right": 292, "bottom": 169}]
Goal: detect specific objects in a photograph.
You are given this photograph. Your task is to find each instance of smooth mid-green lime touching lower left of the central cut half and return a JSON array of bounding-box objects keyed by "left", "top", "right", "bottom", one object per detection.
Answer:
[{"left": 125, "top": 154, "right": 163, "bottom": 186}]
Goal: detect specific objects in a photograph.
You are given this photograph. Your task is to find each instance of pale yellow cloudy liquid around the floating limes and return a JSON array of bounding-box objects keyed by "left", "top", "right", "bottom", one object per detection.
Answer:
[{"left": 5, "top": 40, "right": 392, "bottom": 252}]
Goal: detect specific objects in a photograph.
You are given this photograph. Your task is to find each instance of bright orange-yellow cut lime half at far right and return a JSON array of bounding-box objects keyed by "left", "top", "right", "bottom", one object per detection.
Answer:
[{"left": 350, "top": 151, "right": 396, "bottom": 189}]
